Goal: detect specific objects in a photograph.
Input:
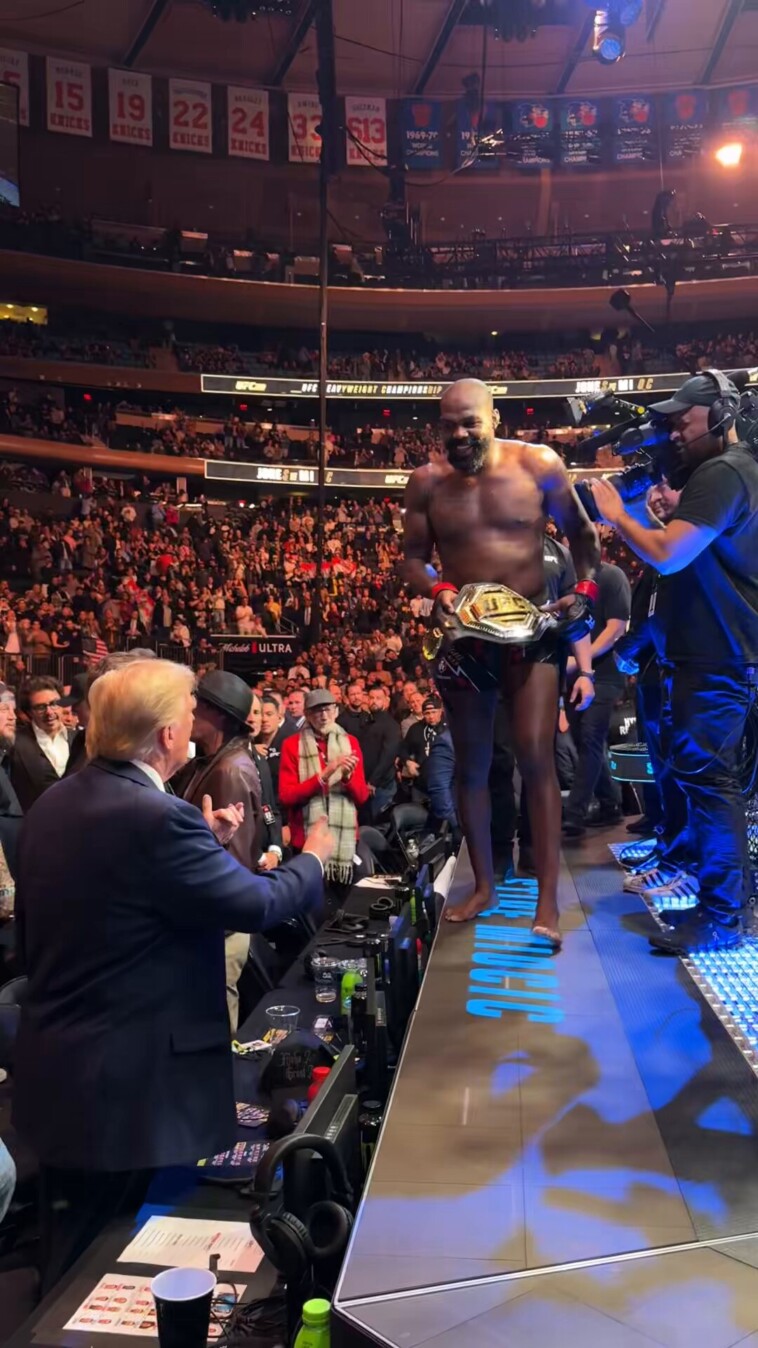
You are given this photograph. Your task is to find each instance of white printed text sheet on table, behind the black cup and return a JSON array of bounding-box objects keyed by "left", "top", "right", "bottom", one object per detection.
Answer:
[{"left": 119, "top": 1217, "right": 263, "bottom": 1273}]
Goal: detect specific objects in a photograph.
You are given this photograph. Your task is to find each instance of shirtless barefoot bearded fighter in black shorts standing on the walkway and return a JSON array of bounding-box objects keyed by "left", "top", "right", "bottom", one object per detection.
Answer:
[{"left": 403, "top": 379, "right": 600, "bottom": 946}]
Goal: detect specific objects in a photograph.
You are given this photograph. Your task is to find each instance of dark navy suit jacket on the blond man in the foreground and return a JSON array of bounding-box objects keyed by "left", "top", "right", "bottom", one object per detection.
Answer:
[{"left": 13, "top": 759, "right": 322, "bottom": 1170}]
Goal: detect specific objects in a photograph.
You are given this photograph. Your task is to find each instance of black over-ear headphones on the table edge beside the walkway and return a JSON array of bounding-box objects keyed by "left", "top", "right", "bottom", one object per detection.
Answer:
[{"left": 250, "top": 1132, "right": 353, "bottom": 1283}]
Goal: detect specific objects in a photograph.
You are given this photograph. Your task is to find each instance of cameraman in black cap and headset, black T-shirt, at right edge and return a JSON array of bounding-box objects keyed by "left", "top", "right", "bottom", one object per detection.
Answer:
[{"left": 592, "top": 371, "right": 758, "bottom": 954}]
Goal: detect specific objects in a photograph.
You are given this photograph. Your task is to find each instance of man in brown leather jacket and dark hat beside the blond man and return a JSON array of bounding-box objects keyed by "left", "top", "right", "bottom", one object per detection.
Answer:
[{"left": 181, "top": 670, "right": 268, "bottom": 1031}]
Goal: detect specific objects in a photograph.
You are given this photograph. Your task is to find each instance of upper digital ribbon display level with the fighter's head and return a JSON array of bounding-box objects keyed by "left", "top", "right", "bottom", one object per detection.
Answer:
[{"left": 200, "top": 373, "right": 688, "bottom": 399}]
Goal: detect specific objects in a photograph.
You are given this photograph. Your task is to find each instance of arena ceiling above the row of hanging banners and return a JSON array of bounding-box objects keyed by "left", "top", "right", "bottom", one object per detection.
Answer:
[{"left": 0, "top": 0, "right": 758, "bottom": 98}]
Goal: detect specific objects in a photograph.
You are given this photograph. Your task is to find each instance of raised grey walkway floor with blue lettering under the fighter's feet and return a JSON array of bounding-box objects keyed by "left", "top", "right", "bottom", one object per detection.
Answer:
[{"left": 332, "top": 837, "right": 758, "bottom": 1348}]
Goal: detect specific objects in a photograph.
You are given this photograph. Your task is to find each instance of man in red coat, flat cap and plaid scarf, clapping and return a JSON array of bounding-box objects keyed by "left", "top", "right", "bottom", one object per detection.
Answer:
[{"left": 279, "top": 687, "right": 368, "bottom": 884}]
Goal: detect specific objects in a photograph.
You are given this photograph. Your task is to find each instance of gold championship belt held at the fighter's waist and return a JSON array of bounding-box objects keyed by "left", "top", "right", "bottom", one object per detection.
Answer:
[{"left": 422, "top": 582, "right": 558, "bottom": 661}]
